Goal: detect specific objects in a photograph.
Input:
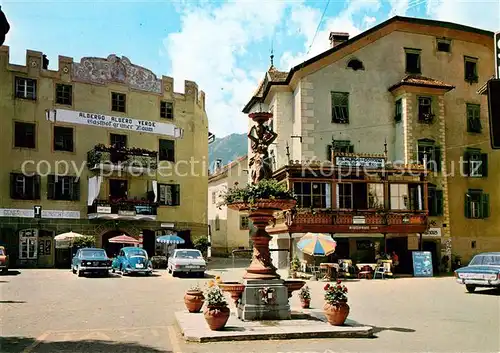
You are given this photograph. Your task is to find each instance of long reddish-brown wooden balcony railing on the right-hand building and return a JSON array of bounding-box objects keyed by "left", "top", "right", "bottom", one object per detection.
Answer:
[{"left": 268, "top": 209, "right": 427, "bottom": 233}]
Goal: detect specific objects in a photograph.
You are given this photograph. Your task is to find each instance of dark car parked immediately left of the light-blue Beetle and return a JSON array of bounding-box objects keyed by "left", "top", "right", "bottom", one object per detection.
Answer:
[{"left": 71, "top": 248, "right": 111, "bottom": 277}]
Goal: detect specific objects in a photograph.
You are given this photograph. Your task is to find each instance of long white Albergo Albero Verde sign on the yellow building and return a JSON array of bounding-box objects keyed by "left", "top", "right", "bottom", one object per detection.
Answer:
[{"left": 46, "top": 109, "right": 184, "bottom": 138}]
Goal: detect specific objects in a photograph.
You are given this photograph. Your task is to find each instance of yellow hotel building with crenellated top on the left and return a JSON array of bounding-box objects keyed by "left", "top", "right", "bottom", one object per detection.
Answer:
[{"left": 0, "top": 46, "right": 208, "bottom": 267}]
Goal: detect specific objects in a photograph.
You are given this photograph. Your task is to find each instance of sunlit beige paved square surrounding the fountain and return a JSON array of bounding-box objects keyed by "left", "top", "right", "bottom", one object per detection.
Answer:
[{"left": 0, "top": 262, "right": 500, "bottom": 353}]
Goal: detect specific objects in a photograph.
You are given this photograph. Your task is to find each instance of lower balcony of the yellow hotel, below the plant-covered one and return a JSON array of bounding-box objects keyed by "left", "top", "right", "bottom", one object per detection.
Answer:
[{"left": 87, "top": 199, "right": 158, "bottom": 221}]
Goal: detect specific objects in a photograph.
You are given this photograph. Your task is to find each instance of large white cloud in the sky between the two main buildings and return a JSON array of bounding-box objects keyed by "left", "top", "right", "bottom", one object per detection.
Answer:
[{"left": 164, "top": 1, "right": 288, "bottom": 136}]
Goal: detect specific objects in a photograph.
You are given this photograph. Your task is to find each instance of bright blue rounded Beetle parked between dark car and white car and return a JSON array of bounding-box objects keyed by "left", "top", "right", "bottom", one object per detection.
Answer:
[{"left": 112, "top": 246, "right": 153, "bottom": 275}]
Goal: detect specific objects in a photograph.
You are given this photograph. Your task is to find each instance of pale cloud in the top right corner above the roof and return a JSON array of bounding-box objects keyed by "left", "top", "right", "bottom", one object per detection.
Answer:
[{"left": 427, "top": 0, "right": 500, "bottom": 31}]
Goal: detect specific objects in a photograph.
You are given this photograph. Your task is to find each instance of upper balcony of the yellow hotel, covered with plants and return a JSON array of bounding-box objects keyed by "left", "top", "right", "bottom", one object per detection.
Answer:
[{"left": 87, "top": 144, "right": 158, "bottom": 174}]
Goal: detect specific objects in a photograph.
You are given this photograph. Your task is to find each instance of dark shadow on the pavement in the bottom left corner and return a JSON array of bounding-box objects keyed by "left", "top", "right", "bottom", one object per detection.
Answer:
[{"left": 0, "top": 337, "right": 173, "bottom": 353}]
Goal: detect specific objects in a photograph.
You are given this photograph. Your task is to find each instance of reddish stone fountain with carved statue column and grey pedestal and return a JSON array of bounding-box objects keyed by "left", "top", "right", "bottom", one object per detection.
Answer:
[{"left": 219, "top": 112, "right": 305, "bottom": 321}]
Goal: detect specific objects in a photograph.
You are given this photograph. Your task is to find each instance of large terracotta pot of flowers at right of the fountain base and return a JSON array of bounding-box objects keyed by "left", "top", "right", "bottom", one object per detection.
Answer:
[{"left": 323, "top": 281, "right": 349, "bottom": 326}]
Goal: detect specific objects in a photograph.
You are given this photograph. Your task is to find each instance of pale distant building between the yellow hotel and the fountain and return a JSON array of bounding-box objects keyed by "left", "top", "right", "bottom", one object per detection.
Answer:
[{"left": 208, "top": 156, "right": 251, "bottom": 256}]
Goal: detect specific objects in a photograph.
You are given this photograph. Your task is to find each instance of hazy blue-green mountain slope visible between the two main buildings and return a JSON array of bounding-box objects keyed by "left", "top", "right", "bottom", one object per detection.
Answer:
[{"left": 208, "top": 133, "right": 248, "bottom": 170}]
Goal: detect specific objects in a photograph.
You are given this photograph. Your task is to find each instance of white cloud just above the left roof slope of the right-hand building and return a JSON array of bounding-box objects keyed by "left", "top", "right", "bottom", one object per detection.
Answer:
[{"left": 281, "top": 0, "right": 381, "bottom": 70}]
